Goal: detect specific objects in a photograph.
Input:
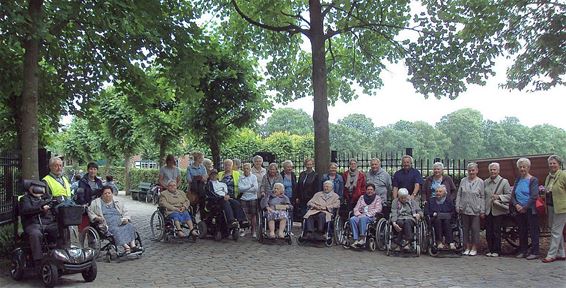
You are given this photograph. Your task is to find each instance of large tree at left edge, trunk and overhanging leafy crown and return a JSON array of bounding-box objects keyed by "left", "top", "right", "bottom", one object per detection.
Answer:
[{"left": 0, "top": 0, "right": 199, "bottom": 178}]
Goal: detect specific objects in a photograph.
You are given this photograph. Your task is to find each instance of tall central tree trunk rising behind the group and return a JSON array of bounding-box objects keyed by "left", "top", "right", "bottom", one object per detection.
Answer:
[{"left": 309, "top": 0, "right": 330, "bottom": 174}]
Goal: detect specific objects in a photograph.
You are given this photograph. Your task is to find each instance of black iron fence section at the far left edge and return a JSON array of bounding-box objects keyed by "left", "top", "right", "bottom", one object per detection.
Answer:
[{"left": 0, "top": 152, "right": 21, "bottom": 225}]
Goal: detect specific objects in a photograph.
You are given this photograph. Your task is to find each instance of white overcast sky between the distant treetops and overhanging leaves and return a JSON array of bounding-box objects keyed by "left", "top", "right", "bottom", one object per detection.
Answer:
[{"left": 276, "top": 58, "right": 566, "bottom": 129}]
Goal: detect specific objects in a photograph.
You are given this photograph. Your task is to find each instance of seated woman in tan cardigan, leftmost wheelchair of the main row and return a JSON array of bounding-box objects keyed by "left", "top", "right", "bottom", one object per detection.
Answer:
[{"left": 159, "top": 180, "right": 199, "bottom": 238}]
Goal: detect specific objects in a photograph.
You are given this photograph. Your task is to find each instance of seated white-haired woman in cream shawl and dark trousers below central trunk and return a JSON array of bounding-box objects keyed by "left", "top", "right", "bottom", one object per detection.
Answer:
[{"left": 303, "top": 180, "right": 340, "bottom": 240}]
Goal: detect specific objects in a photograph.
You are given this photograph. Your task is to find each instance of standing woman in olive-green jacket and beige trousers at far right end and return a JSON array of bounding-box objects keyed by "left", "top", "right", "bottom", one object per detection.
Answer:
[{"left": 542, "top": 155, "right": 566, "bottom": 263}]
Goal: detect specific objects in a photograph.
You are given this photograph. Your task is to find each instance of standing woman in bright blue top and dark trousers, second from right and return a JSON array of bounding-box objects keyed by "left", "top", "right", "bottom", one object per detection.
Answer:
[{"left": 510, "top": 158, "right": 540, "bottom": 260}]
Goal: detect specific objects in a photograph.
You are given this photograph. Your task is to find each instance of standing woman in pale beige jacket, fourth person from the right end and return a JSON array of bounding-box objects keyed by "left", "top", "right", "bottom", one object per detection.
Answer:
[{"left": 456, "top": 162, "right": 485, "bottom": 256}]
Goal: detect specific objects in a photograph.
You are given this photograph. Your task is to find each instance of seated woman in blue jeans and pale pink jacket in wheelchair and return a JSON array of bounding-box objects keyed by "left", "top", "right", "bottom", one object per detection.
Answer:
[{"left": 349, "top": 183, "right": 382, "bottom": 247}]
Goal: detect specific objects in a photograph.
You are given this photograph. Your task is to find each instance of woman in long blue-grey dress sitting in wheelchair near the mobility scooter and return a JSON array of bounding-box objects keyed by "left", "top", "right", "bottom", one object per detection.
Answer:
[{"left": 89, "top": 186, "right": 143, "bottom": 254}]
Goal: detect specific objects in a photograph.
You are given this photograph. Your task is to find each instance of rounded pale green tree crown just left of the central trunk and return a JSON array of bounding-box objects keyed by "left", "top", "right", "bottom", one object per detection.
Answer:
[{"left": 262, "top": 108, "right": 313, "bottom": 136}]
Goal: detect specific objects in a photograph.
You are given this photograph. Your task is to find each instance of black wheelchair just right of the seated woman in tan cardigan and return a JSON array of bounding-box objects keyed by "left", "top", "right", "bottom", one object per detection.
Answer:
[{"left": 198, "top": 199, "right": 249, "bottom": 241}]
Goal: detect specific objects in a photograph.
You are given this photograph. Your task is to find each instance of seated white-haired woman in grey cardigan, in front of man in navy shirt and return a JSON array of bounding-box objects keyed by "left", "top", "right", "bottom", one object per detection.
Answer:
[{"left": 391, "top": 188, "right": 423, "bottom": 250}]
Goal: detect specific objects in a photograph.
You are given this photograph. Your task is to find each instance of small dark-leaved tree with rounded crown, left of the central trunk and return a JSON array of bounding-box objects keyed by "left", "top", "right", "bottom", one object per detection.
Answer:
[{"left": 184, "top": 45, "right": 267, "bottom": 168}]
